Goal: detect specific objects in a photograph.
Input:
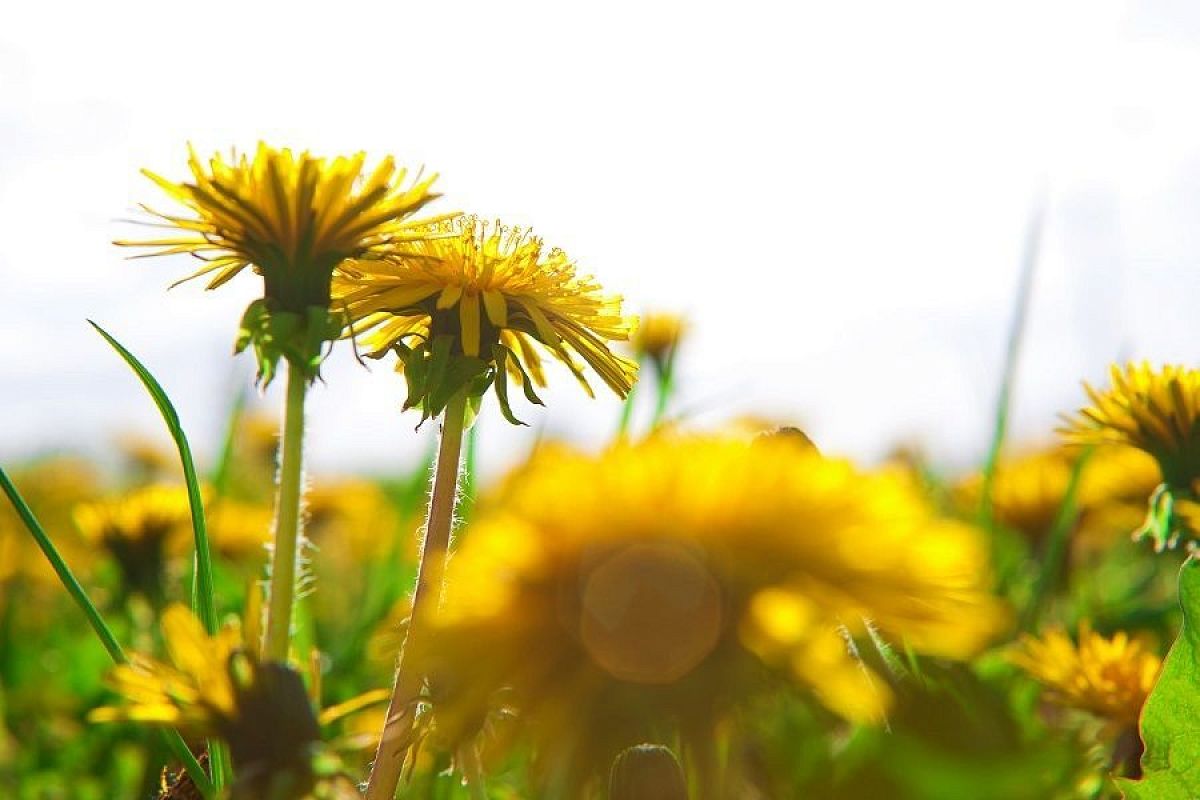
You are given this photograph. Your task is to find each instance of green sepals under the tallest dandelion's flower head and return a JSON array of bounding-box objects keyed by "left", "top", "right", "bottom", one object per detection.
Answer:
[{"left": 234, "top": 299, "right": 346, "bottom": 387}]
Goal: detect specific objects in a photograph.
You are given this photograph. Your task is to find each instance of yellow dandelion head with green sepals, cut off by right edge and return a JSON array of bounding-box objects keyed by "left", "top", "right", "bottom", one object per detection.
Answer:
[{"left": 1062, "top": 361, "right": 1200, "bottom": 549}]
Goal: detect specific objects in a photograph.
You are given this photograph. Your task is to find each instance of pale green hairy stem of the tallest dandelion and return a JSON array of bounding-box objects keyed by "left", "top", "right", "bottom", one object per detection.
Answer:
[{"left": 263, "top": 363, "right": 308, "bottom": 662}]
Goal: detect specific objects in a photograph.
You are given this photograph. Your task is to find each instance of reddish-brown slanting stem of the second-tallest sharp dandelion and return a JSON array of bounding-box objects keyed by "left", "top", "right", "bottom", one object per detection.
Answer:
[{"left": 366, "top": 391, "right": 467, "bottom": 800}]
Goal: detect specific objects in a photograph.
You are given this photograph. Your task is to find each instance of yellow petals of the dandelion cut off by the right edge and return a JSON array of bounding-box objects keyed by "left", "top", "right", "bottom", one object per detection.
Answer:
[{"left": 1062, "top": 361, "right": 1200, "bottom": 487}]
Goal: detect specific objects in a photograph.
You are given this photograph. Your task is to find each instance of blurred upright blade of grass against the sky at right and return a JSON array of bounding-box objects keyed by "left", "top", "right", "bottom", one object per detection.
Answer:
[{"left": 979, "top": 192, "right": 1046, "bottom": 531}]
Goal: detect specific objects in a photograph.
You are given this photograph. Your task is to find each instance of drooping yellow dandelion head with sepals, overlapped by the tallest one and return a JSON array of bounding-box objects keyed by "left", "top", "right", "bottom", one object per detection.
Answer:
[{"left": 335, "top": 217, "right": 637, "bottom": 422}]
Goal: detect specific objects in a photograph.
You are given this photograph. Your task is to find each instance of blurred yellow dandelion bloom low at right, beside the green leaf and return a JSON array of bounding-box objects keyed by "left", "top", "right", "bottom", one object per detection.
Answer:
[{"left": 1010, "top": 624, "right": 1163, "bottom": 727}]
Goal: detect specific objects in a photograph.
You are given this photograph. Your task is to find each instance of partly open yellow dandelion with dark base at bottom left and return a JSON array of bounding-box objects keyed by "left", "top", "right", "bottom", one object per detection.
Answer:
[{"left": 90, "top": 604, "right": 320, "bottom": 800}]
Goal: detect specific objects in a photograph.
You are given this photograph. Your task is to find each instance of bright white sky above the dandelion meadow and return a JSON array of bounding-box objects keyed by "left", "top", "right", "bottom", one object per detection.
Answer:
[{"left": 0, "top": 0, "right": 1200, "bottom": 479}]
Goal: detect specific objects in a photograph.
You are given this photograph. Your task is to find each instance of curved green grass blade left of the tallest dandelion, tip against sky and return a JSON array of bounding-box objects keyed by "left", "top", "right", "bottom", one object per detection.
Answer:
[{"left": 88, "top": 319, "right": 229, "bottom": 789}]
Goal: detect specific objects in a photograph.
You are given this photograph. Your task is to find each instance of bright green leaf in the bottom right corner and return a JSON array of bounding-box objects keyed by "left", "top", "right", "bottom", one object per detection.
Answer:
[{"left": 1118, "top": 557, "right": 1200, "bottom": 800}]
